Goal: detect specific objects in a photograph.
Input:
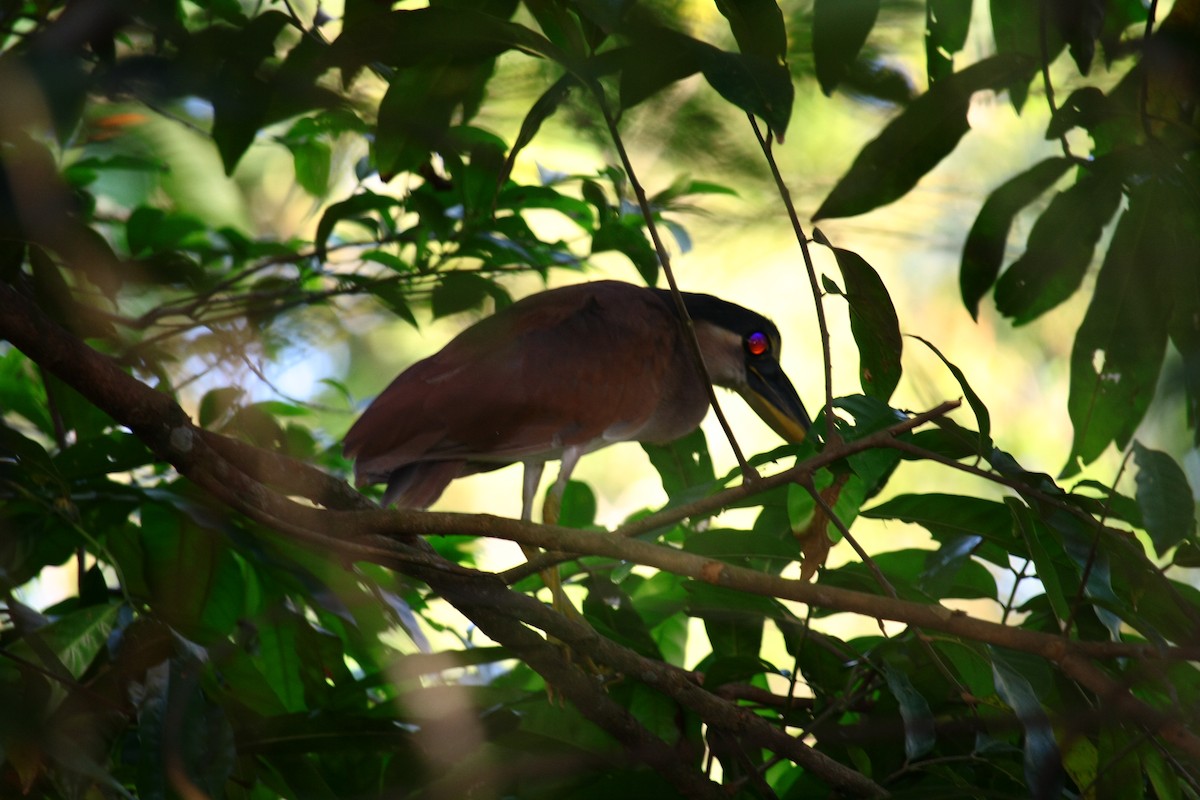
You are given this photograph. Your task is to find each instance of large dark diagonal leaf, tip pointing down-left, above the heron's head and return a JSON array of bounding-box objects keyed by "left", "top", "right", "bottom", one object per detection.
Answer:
[{"left": 812, "top": 55, "right": 1036, "bottom": 219}]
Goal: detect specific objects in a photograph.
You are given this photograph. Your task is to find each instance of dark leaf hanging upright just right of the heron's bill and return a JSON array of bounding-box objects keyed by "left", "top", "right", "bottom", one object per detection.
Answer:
[{"left": 833, "top": 247, "right": 904, "bottom": 402}]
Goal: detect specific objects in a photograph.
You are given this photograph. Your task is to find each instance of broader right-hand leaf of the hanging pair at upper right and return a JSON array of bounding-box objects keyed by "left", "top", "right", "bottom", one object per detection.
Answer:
[{"left": 996, "top": 162, "right": 1122, "bottom": 325}]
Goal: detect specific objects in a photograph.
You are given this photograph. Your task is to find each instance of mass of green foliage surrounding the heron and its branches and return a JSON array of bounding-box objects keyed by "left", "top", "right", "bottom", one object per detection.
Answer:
[{"left": 0, "top": 0, "right": 1200, "bottom": 799}]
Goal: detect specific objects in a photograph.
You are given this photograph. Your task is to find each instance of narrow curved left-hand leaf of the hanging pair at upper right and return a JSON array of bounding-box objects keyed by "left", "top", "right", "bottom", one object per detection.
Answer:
[{"left": 959, "top": 157, "right": 1073, "bottom": 319}]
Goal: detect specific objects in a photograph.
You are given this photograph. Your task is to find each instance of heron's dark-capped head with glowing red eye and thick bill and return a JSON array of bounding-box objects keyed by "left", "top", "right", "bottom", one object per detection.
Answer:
[{"left": 660, "top": 290, "right": 811, "bottom": 443}]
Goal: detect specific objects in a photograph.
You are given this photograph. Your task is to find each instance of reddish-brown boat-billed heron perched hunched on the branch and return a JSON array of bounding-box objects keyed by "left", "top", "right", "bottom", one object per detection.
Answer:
[{"left": 344, "top": 281, "right": 809, "bottom": 523}]
